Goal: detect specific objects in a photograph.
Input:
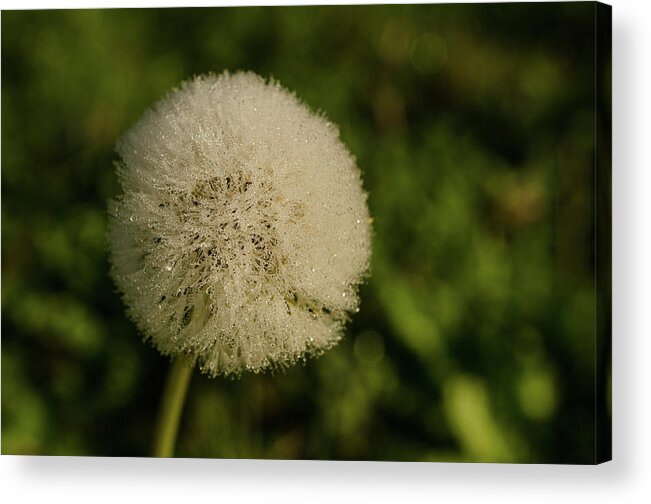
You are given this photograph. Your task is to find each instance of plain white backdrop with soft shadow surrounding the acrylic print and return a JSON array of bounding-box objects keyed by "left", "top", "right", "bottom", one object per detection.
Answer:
[{"left": 0, "top": 0, "right": 651, "bottom": 504}]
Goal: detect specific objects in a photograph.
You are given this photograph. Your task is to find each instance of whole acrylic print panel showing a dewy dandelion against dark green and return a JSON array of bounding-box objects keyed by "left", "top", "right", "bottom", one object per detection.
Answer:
[{"left": 2, "top": 2, "right": 611, "bottom": 464}]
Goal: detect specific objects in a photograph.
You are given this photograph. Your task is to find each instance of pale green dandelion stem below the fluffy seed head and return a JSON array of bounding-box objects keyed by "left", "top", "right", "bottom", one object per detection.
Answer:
[{"left": 153, "top": 357, "right": 193, "bottom": 457}]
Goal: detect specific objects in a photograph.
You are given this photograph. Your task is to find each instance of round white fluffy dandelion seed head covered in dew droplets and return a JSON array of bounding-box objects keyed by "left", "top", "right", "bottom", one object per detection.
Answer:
[{"left": 109, "top": 73, "right": 371, "bottom": 376}]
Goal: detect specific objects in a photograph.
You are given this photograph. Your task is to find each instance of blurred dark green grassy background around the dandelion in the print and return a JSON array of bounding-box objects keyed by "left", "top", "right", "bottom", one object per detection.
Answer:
[{"left": 2, "top": 3, "right": 608, "bottom": 463}]
